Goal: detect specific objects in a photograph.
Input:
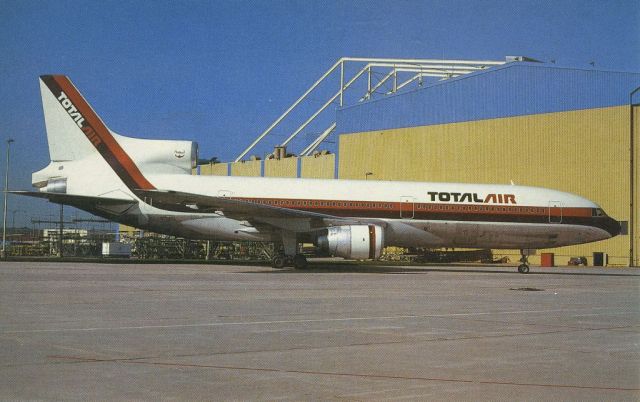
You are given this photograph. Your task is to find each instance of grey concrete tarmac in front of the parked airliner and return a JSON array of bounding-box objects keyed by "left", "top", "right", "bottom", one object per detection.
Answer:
[{"left": 0, "top": 262, "right": 640, "bottom": 401}]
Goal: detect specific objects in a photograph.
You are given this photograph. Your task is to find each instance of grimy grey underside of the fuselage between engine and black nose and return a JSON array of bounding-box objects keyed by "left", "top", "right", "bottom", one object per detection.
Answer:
[{"left": 385, "top": 220, "right": 610, "bottom": 249}]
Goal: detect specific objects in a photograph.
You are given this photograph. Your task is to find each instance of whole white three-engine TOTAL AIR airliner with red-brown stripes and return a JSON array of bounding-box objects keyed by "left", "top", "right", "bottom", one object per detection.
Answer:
[{"left": 13, "top": 75, "right": 620, "bottom": 273}]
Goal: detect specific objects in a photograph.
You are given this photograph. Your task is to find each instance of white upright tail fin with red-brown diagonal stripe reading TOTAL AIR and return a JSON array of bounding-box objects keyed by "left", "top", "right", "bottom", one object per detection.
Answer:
[{"left": 40, "top": 75, "right": 155, "bottom": 190}]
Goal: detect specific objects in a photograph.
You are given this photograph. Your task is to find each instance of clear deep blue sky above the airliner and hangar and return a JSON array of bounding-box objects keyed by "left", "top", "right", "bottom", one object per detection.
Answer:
[{"left": 0, "top": 0, "right": 640, "bottom": 224}]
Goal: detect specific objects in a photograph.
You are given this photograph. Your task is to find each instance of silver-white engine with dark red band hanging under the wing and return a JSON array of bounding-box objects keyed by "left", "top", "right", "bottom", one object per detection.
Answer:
[{"left": 317, "top": 225, "right": 384, "bottom": 260}]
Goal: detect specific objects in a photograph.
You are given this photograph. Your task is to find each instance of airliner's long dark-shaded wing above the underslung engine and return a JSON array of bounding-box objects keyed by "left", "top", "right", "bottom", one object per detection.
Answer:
[{"left": 136, "top": 190, "right": 386, "bottom": 232}]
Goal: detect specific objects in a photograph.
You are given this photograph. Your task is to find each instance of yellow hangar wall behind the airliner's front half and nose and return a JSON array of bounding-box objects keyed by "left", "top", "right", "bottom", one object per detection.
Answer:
[{"left": 338, "top": 106, "right": 640, "bottom": 266}]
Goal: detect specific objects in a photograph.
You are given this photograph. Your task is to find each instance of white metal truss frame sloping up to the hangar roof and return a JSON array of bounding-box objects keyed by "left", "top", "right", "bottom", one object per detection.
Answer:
[{"left": 235, "top": 57, "right": 506, "bottom": 162}]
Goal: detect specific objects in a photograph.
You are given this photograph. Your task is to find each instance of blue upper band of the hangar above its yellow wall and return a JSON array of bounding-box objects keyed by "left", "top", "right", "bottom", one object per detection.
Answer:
[{"left": 337, "top": 62, "right": 640, "bottom": 134}]
